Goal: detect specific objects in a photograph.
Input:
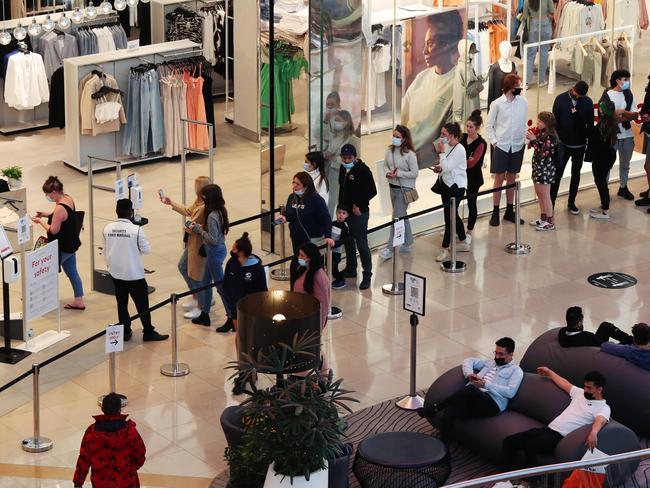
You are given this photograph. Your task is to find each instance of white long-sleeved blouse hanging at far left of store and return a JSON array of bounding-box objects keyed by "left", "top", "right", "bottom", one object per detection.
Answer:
[{"left": 5, "top": 52, "right": 50, "bottom": 110}]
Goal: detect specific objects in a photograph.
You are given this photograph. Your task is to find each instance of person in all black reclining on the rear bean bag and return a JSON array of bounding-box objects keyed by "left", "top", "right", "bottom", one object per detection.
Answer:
[{"left": 557, "top": 307, "right": 632, "bottom": 347}]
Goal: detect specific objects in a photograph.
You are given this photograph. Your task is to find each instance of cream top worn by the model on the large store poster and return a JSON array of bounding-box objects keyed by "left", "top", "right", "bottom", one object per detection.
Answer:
[{"left": 401, "top": 67, "right": 457, "bottom": 160}]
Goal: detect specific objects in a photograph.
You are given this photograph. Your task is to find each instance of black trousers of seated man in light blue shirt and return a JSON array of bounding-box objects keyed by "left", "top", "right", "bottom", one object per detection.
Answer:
[{"left": 438, "top": 385, "right": 500, "bottom": 442}]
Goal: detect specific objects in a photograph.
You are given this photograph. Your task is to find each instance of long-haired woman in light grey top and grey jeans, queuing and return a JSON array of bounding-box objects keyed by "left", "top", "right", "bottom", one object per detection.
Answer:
[{"left": 379, "top": 125, "right": 419, "bottom": 260}]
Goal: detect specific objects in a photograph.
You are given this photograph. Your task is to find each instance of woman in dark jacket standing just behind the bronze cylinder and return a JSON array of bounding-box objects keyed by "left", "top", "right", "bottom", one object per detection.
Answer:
[{"left": 217, "top": 232, "right": 268, "bottom": 395}]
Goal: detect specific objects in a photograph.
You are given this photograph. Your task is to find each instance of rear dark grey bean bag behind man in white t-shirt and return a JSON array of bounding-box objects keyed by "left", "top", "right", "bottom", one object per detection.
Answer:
[{"left": 521, "top": 329, "right": 650, "bottom": 437}]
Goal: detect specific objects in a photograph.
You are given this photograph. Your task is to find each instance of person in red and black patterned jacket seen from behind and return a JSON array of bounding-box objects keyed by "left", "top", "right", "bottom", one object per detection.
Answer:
[{"left": 73, "top": 393, "right": 146, "bottom": 488}]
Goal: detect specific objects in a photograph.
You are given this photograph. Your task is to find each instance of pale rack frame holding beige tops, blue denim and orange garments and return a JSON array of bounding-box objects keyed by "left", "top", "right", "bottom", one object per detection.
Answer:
[{"left": 63, "top": 40, "right": 201, "bottom": 173}]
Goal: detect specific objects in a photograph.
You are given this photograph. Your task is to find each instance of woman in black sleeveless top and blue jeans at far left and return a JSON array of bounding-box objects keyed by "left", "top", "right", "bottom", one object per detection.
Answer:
[{"left": 32, "top": 176, "right": 86, "bottom": 310}]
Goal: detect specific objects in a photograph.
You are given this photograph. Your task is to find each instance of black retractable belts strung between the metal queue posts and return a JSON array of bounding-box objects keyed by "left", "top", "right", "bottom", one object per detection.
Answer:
[{"left": 0, "top": 183, "right": 517, "bottom": 393}]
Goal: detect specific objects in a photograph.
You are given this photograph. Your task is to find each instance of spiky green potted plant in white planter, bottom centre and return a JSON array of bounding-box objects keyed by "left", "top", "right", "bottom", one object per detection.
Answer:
[{"left": 226, "top": 333, "right": 357, "bottom": 488}]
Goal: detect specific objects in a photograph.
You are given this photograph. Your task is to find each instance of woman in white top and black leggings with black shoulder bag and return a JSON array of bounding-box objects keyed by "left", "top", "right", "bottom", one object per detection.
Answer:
[{"left": 431, "top": 122, "right": 472, "bottom": 262}]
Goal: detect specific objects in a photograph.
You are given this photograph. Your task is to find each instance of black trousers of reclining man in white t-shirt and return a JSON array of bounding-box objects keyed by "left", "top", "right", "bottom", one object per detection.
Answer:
[{"left": 503, "top": 427, "right": 562, "bottom": 469}]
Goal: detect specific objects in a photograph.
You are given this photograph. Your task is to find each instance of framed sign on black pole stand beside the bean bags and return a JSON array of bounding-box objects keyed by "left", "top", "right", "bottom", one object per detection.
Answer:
[{"left": 397, "top": 271, "right": 427, "bottom": 410}]
